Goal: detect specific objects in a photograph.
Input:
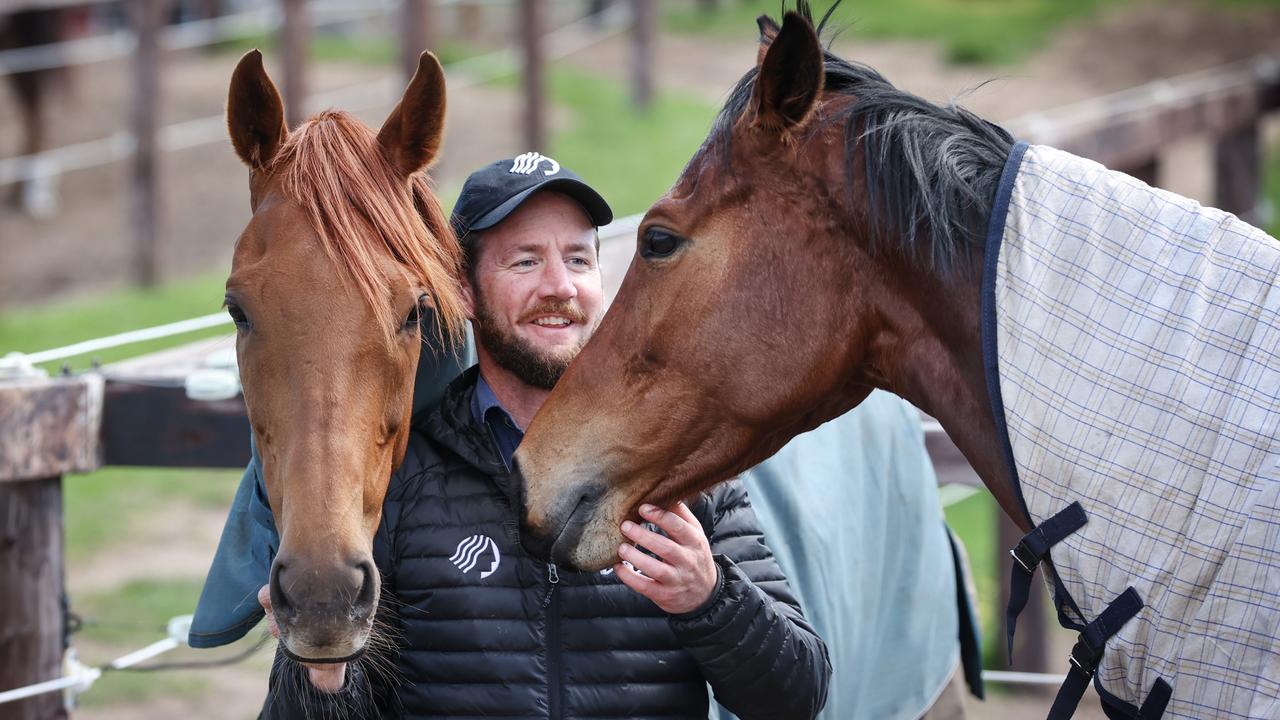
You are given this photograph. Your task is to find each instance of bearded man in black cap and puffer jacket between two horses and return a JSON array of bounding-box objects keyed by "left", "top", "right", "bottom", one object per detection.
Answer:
[{"left": 189, "top": 154, "right": 831, "bottom": 720}]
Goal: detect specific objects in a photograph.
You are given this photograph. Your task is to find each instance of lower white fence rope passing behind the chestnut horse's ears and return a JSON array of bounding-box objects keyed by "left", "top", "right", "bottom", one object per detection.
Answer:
[{"left": 0, "top": 5, "right": 626, "bottom": 184}]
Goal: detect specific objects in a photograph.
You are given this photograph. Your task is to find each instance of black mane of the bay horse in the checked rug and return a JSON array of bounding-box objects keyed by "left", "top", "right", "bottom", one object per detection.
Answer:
[{"left": 704, "top": 0, "right": 1014, "bottom": 275}]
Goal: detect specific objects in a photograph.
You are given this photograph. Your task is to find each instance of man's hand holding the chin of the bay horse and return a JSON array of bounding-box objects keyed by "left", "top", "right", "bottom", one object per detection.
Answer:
[{"left": 613, "top": 502, "right": 719, "bottom": 615}]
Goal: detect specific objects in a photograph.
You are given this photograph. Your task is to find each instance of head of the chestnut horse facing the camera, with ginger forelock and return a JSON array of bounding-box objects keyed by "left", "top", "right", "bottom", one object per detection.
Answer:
[{"left": 225, "top": 50, "right": 463, "bottom": 662}]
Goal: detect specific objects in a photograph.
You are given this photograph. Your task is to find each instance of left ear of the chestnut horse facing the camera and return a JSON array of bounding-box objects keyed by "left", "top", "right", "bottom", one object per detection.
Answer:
[{"left": 227, "top": 50, "right": 289, "bottom": 170}]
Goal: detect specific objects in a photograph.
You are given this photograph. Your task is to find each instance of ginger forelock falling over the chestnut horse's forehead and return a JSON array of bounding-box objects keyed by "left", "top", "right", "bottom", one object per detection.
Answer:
[{"left": 271, "top": 110, "right": 466, "bottom": 347}]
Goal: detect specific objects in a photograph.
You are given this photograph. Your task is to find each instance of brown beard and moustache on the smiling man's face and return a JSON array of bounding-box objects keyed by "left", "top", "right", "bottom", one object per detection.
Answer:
[{"left": 471, "top": 296, "right": 595, "bottom": 389}]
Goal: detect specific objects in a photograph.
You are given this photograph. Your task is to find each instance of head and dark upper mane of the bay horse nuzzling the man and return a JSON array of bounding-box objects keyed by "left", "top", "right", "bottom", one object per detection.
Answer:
[{"left": 516, "top": 3, "right": 1012, "bottom": 568}]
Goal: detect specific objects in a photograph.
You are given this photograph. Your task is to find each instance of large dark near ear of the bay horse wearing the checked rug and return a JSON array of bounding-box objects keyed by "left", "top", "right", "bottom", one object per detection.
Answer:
[{"left": 751, "top": 13, "right": 823, "bottom": 131}]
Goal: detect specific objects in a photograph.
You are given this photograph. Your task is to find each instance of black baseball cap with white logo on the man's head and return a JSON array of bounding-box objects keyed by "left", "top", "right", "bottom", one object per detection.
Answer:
[{"left": 449, "top": 152, "right": 613, "bottom": 243}]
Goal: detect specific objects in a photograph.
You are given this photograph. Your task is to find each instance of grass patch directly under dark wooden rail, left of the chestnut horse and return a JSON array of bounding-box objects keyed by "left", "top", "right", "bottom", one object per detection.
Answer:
[{"left": 63, "top": 468, "right": 240, "bottom": 564}]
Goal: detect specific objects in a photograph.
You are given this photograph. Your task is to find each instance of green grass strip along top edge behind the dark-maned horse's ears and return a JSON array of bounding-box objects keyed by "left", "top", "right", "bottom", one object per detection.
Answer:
[{"left": 664, "top": 0, "right": 1115, "bottom": 64}]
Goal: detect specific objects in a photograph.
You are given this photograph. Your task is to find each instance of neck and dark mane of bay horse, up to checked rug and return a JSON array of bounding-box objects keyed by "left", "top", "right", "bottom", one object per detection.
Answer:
[{"left": 796, "top": 75, "right": 1029, "bottom": 529}]
